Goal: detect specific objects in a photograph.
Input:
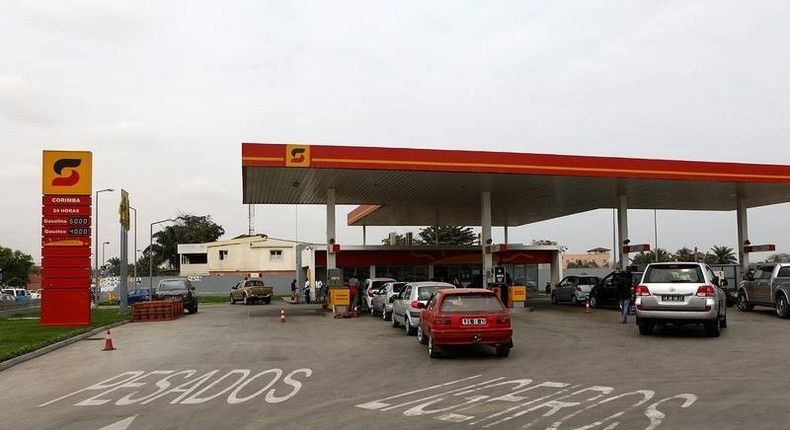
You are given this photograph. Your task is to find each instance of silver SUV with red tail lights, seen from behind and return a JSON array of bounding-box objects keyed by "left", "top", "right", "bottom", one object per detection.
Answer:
[{"left": 634, "top": 262, "right": 727, "bottom": 337}]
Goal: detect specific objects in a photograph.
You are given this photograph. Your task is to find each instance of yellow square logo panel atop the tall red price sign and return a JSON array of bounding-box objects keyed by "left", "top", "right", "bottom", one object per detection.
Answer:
[{"left": 42, "top": 151, "right": 93, "bottom": 196}]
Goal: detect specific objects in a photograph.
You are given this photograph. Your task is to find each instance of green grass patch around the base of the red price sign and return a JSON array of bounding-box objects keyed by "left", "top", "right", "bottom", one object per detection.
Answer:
[{"left": 0, "top": 308, "right": 129, "bottom": 361}]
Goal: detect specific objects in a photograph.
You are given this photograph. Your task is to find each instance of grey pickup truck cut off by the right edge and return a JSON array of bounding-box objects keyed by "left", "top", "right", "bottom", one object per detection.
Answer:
[{"left": 738, "top": 263, "right": 790, "bottom": 318}]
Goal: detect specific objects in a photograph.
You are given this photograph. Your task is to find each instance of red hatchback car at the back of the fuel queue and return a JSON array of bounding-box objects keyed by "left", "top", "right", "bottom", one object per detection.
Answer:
[{"left": 417, "top": 288, "right": 513, "bottom": 358}]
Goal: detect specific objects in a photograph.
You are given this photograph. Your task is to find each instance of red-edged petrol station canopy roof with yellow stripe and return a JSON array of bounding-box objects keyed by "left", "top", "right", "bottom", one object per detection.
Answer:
[{"left": 242, "top": 143, "right": 790, "bottom": 226}]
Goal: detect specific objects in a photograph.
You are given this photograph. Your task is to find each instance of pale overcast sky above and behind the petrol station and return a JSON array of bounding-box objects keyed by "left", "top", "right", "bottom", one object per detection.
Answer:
[{"left": 0, "top": 0, "right": 790, "bottom": 262}]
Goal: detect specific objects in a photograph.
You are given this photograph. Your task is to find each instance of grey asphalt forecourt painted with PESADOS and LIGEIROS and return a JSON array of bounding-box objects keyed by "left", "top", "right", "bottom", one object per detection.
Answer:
[{"left": 0, "top": 298, "right": 790, "bottom": 430}]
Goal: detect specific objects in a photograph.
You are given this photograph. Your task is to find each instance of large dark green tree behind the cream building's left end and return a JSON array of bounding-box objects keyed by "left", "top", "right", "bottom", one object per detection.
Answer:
[{"left": 146, "top": 214, "right": 225, "bottom": 275}]
